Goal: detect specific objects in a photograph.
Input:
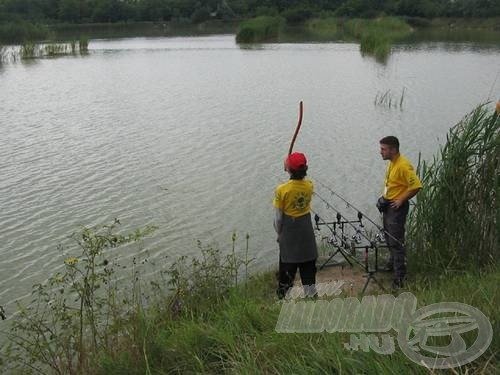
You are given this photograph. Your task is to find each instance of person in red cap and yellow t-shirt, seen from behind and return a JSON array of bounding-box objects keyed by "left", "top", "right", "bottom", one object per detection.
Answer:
[{"left": 273, "top": 152, "right": 318, "bottom": 298}]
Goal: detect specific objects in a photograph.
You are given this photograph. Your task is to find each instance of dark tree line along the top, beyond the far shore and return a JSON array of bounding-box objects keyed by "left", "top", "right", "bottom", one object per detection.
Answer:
[{"left": 0, "top": 0, "right": 500, "bottom": 23}]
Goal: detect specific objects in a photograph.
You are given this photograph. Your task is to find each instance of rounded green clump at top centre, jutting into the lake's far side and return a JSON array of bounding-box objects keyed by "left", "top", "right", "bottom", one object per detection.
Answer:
[{"left": 236, "top": 16, "right": 284, "bottom": 43}]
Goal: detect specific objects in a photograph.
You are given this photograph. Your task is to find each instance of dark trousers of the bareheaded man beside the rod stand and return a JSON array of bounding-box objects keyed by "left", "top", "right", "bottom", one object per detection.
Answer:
[{"left": 383, "top": 201, "right": 410, "bottom": 280}]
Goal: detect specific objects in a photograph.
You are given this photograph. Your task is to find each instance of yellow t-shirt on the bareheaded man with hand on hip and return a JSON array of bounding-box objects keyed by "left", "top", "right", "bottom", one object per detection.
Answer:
[{"left": 384, "top": 155, "right": 422, "bottom": 201}]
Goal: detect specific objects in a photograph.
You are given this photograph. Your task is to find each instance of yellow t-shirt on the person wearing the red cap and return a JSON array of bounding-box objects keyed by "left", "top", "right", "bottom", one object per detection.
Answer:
[{"left": 273, "top": 180, "right": 314, "bottom": 217}]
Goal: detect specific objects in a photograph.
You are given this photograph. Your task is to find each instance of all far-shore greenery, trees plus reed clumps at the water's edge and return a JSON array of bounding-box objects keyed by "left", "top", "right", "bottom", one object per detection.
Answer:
[{"left": 0, "top": 0, "right": 500, "bottom": 63}]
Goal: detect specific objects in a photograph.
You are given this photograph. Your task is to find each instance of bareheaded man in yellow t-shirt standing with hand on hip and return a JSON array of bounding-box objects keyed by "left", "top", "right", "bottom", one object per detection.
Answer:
[{"left": 378, "top": 136, "right": 422, "bottom": 289}]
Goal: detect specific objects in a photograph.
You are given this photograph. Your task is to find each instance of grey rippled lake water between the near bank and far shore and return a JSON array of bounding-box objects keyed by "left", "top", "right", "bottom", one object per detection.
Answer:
[{"left": 0, "top": 35, "right": 500, "bottom": 310}]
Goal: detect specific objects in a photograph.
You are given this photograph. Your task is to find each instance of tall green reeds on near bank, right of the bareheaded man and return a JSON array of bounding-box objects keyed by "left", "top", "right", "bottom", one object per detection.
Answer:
[{"left": 408, "top": 104, "right": 500, "bottom": 272}]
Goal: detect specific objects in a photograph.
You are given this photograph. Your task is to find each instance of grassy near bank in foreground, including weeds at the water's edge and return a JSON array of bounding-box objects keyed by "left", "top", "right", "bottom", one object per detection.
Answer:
[{"left": 5, "top": 239, "right": 500, "bottom": 375}]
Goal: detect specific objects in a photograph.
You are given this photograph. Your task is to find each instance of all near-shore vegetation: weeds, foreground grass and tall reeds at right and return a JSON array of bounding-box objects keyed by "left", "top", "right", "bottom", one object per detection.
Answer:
[{"left": 0, "top": 104, "right": 500, "bottom": 375}]
